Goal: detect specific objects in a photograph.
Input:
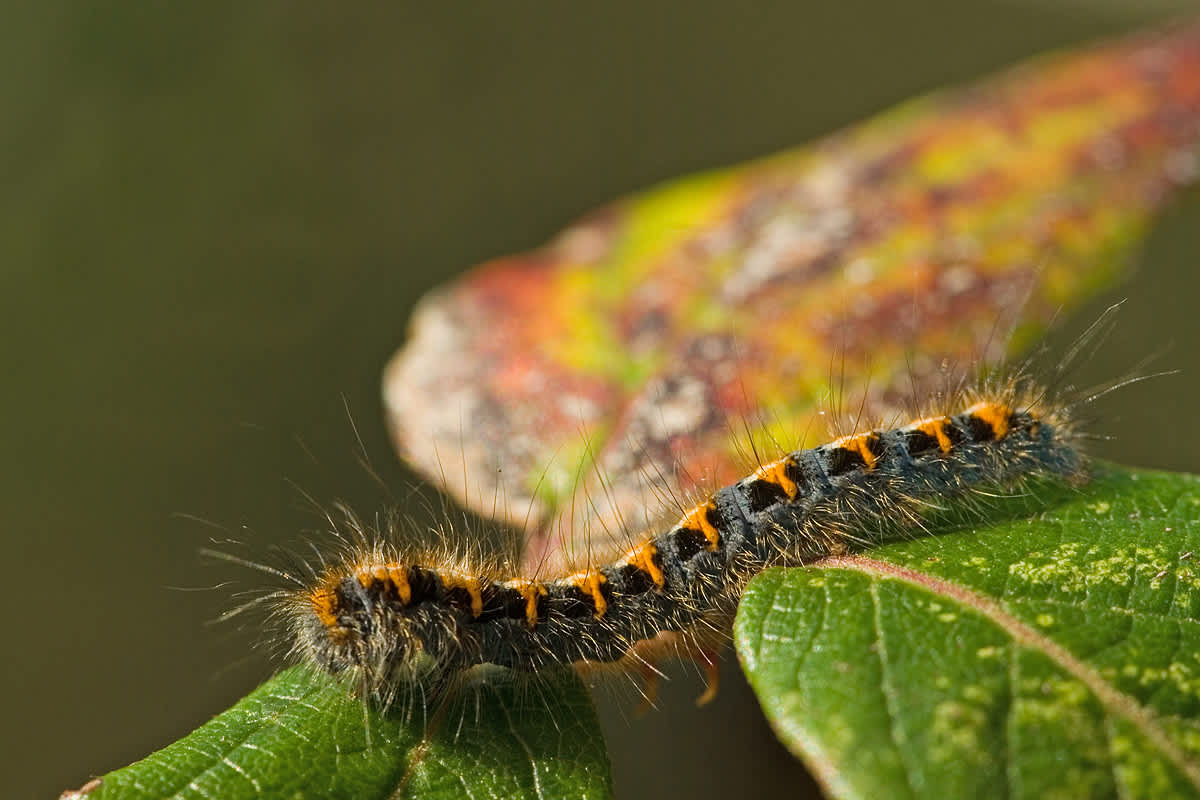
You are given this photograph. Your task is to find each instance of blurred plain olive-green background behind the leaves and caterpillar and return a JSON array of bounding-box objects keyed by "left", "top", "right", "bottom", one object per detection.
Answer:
[{"left": 9, "top": 0, "right": 1200, "bottom": 799}]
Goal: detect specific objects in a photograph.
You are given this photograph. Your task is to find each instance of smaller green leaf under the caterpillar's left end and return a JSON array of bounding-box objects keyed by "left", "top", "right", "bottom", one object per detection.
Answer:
[{"left": 88, "top": 667, "right": 612, "bottom": 800}]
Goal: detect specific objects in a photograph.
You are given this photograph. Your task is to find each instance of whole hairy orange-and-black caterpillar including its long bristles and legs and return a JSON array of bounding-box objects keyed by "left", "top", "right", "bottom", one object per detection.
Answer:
[{"left": 206, "top": 306, "right": 1142, "bottom": 712}]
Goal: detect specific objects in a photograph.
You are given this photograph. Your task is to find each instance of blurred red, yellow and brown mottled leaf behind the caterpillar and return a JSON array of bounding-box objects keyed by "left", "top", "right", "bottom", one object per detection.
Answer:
[{"left": 385, "top": 26, "right": 1200, "bottom": 569}]
